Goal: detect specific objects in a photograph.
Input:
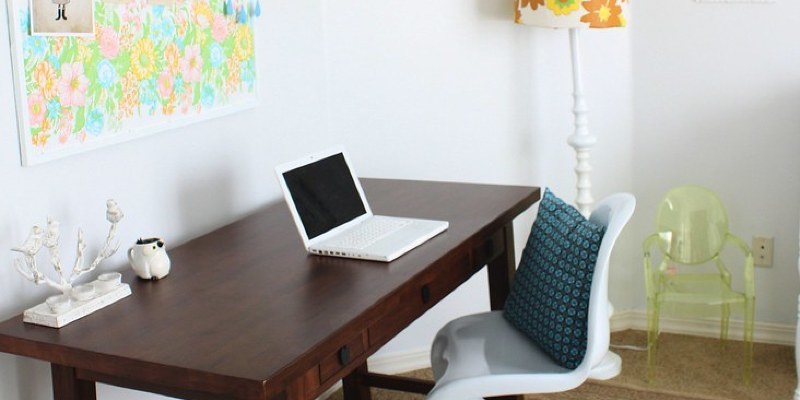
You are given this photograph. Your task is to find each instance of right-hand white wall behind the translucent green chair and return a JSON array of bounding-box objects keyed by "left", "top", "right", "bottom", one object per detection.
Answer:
[{"left": 628, "top": 0, "right": 800, "bottom": 326}]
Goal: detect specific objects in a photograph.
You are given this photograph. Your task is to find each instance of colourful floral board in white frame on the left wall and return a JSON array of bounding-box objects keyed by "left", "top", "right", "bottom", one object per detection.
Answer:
[{"left": 7, "top": 0, "right": 260, "bottom": 165}]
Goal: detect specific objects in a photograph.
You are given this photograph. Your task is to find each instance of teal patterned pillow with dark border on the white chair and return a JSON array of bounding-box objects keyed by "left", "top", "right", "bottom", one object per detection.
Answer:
[{"left": 503, "top": 189, "right": 605, "bottom": 369}]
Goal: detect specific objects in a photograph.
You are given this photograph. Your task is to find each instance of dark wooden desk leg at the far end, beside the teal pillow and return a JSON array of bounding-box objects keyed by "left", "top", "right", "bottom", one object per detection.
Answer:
[{"left": 488, "top": 222, "right": 524, "bottom": 400}]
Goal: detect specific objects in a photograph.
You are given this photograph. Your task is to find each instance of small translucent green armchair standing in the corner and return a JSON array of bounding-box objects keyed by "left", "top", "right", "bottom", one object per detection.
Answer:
[{"left": 643, "top": 185, "right": 755, "bottom": 382}]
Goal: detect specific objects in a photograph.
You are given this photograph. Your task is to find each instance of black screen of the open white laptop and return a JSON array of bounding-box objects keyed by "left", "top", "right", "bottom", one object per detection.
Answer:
[{"left": 283, "top": 153, "right": 367, "bottom": 239}]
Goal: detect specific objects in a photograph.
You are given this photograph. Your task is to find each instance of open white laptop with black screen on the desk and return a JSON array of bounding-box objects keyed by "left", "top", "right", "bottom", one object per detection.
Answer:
[{"left": 275, "top": 147, "right": 448, "bottom": 261}]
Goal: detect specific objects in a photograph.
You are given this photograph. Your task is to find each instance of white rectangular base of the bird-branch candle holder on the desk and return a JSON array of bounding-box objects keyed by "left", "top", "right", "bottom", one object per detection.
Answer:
[{"left": 22, "top": 282, "right": 131, "bottom": 328}]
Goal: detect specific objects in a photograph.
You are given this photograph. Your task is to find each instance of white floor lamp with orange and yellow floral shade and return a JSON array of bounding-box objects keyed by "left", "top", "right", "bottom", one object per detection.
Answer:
[{"left": 514, "top": 0, "right": 628, "bottom": 379}]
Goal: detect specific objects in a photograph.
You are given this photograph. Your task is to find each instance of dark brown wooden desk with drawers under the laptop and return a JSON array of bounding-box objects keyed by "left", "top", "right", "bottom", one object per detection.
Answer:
[{"left": 0, "top": 179, "right": 540, "bottom": 400}]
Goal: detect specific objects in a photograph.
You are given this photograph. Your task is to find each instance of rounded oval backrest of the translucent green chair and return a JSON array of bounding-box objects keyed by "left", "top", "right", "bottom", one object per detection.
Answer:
[{"left": 656, "top": 185, "right": 728, "bottom": 264}]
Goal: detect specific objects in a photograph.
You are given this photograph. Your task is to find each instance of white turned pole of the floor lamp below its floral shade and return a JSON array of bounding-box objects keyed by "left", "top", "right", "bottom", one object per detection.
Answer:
[{"left": 567, "top": 28, "right": 597, "bottom": 218}]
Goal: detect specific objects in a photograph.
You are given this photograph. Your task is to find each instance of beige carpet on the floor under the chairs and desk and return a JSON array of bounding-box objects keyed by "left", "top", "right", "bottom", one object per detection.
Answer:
[{"left": 329, "top": 331, "right": 797, "bottom": 400}]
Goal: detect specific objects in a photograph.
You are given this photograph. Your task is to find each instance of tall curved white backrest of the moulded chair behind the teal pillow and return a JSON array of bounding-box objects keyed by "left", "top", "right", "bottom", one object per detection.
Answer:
[{"left": 580, "top": 193, "right": 636, "bottom": 369}]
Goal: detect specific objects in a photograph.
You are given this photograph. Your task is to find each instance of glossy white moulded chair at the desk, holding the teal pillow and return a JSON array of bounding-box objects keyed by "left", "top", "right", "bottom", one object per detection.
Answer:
[{"left": 427, "top": 193, "right": 636, "bottom": 400}]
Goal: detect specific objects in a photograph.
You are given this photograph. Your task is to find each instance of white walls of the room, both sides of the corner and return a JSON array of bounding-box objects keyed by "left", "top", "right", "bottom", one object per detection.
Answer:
[{"left": 7, "top": 0, "right": 800, "bottom": 400}]
